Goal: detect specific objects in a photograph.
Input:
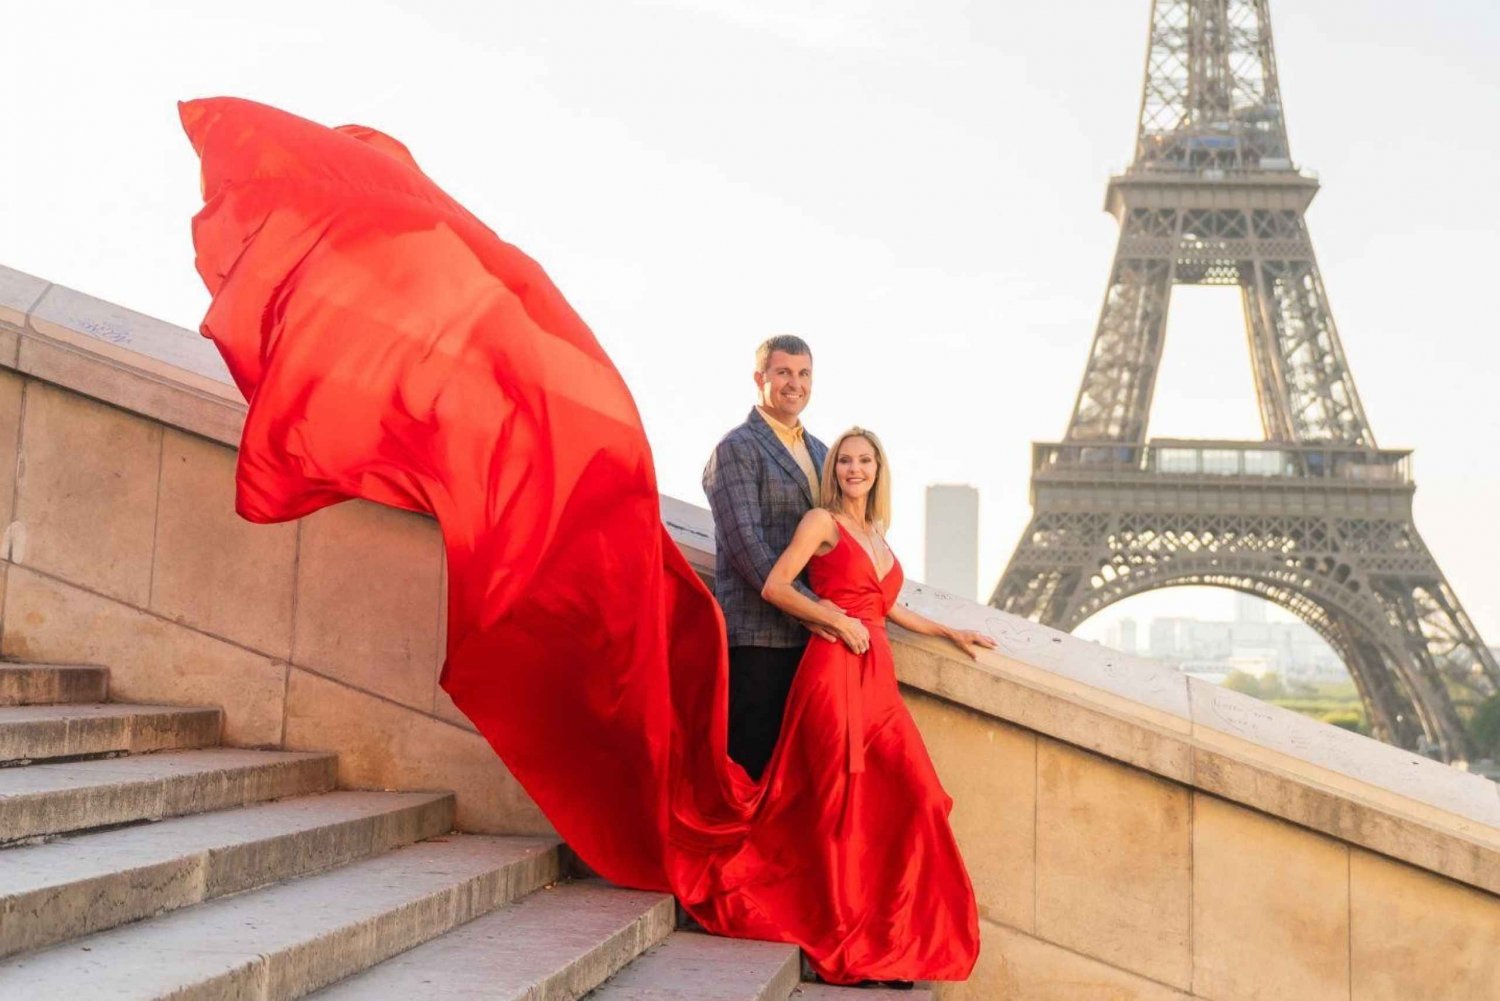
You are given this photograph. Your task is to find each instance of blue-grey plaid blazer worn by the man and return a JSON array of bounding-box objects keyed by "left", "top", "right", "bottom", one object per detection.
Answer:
[{"left": 704, "top": 408, "right": 828, "bottom": 648}]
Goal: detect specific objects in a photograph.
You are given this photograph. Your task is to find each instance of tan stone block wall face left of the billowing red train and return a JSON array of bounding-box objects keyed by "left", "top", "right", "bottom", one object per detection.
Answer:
[{"left": 0, "top": 371, "right": 549, "bottom": 833}]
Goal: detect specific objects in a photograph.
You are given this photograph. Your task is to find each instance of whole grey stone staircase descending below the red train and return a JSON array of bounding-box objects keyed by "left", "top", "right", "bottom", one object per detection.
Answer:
[{"left": 0, "top": 663, "right": 930, "bottom": 1001}]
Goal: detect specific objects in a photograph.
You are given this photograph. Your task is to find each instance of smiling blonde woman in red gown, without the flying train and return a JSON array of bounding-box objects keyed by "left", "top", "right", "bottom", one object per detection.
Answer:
[{"left": 690, "top": 428, "right": 995, "bottom": 986}]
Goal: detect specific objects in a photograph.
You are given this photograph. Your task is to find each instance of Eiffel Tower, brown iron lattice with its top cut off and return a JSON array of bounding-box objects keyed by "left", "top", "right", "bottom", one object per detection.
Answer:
[{"left": 990, "top": 0, "right": 1500, "bottom": 761}]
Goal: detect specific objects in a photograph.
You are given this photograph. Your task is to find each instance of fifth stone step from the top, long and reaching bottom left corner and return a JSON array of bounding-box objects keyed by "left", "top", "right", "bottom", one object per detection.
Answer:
[{"left": 0, "top": 834, "right": 560, "bottom": 1001}]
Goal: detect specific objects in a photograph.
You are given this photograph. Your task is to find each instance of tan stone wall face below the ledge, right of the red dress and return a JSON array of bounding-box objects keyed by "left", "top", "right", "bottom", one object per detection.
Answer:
[{"left": 908, "top": 690, "right": 1500, "bottom": 1001}]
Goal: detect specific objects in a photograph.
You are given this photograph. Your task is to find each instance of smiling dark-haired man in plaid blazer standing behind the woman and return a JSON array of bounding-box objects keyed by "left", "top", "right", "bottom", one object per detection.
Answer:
[{"left": 704, "top": 335, "right": 831, "bottom": 779}]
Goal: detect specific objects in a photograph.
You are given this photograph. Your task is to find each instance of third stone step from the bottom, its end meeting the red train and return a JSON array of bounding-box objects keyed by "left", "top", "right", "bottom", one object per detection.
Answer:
[{"left": 312, "top": 879, "right": 672, "bottom": 1001}]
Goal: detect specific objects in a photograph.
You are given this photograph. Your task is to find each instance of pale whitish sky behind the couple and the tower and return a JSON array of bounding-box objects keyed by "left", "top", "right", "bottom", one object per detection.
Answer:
[{"left": 0, "top": 0, "right": 1500, "bottom": 644}]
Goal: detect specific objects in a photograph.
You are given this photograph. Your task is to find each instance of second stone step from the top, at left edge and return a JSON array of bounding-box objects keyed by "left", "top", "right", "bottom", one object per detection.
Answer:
[{"left": 0, "top": 702, "right": 219, "bottom": 764}]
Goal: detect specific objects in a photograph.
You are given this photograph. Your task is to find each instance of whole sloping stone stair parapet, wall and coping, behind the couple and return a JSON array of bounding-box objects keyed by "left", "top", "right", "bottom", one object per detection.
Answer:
[{"left": 0, "top": 269, "right": 1500, "bottom": 1001}]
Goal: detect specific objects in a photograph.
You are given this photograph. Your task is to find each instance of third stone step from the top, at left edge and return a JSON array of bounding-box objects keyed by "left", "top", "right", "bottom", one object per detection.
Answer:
[{"left": 0, "top": 747, "right": 338, "bottom": 840}]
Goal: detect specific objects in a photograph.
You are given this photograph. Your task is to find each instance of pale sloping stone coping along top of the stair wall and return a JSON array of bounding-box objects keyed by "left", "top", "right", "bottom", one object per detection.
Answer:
[{"left": 0, "top": 267, "right": 1500, "bottom": 893}]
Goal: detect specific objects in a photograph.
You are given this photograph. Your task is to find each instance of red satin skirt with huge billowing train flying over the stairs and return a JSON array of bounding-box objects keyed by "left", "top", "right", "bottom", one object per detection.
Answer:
[{"left": 182, "top": 99, "right": 978, "bottom": 980}]
